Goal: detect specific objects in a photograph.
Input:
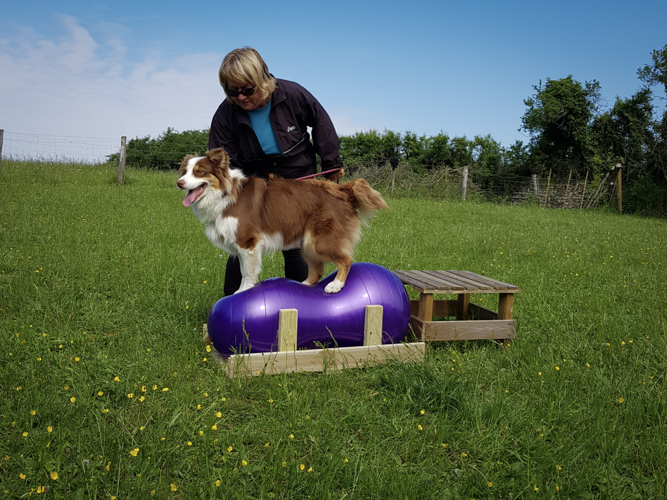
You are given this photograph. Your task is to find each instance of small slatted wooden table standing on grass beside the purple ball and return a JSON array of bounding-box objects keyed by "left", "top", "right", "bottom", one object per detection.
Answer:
[{"left": 394, "top": 271, "right": 521, "bottom": 342}]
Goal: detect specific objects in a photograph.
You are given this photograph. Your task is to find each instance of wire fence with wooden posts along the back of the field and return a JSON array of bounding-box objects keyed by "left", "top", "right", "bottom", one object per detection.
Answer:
[{"left": 0, "top": 130, "right": 620, "bottom": 210}]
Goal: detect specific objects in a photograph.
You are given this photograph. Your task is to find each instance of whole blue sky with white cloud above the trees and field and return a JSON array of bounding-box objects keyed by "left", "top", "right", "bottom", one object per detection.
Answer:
[{"left": 0, "top": 0, "right": 667, "bottom": 146}]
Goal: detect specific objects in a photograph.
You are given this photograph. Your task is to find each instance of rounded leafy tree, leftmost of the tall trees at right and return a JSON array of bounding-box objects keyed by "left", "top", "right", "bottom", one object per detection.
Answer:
[{"left": 521, "top": 75, "right": 600, "bottom": 175}]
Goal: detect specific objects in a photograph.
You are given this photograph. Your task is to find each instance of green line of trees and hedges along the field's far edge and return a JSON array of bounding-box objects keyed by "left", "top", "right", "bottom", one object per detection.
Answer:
[{"left": 109, "top": 45, "right": 667, "bottom": 215}]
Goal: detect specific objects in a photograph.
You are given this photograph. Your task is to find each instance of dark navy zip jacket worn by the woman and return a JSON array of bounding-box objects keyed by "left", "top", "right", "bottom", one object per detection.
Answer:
[{"left": 208, "top": 79, "right": 343, "bottom": 179}]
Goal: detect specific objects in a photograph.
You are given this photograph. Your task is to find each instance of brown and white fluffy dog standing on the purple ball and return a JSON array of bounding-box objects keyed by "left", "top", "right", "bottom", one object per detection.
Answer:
[{"left": 176, "top": 148, "right": 387, "bottom": 293}]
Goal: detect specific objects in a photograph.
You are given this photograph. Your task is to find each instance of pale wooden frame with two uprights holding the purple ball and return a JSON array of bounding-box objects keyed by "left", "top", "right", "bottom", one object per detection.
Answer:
[{"left": 204, "top": 305, "right": 426, "bottom": 377}]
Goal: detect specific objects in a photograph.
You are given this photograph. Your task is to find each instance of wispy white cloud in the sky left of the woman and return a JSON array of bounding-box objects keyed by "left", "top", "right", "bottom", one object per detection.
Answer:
[{"left": 0, "top": 16, "right": 224, "bottom": 145}]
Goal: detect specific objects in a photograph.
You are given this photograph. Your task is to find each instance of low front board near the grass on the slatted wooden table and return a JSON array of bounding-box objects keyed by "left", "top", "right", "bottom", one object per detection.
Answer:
[{"left": 424, "top": 319, "right": 516, "bottom": 342}]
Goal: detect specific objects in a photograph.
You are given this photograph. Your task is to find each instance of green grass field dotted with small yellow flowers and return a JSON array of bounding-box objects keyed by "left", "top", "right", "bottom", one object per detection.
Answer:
[{"left": 0, "top": 161, "right": 667, "bottom": 499}]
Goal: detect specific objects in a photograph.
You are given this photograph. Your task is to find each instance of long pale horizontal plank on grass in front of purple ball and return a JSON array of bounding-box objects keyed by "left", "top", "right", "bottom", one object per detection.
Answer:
[{"left": 221, "top": 342, "right": 426, "bottom": 377}]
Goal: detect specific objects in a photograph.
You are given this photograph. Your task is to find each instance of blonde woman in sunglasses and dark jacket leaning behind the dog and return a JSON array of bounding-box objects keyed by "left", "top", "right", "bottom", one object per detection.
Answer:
[{"left": 208, "top": 47, "right": 343, "bottom": 295}]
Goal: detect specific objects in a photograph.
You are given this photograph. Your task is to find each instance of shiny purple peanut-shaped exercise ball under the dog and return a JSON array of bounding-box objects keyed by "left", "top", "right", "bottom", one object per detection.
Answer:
[{"left": 208, "top": 262, "right": 410, "bottom": 356}]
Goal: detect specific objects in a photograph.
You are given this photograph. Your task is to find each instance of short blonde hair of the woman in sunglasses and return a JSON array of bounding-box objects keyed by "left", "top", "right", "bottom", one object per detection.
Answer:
[{"left": 218, "top": 47, "right": 276, "bottom": 100}]
